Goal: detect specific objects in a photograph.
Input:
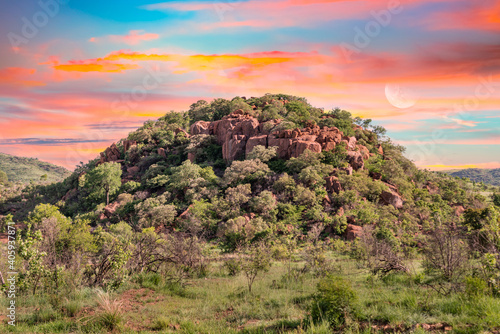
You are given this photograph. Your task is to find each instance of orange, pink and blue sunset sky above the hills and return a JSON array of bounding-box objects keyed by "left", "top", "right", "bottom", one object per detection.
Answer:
[{"left": 0, "top": 0, "right": 500, "bottom": 170}]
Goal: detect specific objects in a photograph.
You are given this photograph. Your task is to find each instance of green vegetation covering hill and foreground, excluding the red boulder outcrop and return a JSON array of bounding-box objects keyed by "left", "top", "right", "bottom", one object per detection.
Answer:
[{"left": 0, "top": 95, "right": 500, "bottom": 333}]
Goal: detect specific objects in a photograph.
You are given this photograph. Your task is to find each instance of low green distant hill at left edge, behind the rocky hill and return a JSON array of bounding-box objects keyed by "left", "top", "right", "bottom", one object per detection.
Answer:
[{"left": 0, "top": 153, "right": 71, "bottom": 183}]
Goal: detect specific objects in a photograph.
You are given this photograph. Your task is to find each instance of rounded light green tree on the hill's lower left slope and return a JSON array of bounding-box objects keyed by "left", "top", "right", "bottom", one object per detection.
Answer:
[{"left": 85, "top": 162, "right": 122, "bottom": 205}]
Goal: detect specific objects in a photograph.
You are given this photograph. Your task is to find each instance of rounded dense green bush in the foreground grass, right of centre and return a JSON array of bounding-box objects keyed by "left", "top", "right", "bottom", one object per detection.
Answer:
[{"left": 311, "top": 276, "right": 357, "bottom": 328}]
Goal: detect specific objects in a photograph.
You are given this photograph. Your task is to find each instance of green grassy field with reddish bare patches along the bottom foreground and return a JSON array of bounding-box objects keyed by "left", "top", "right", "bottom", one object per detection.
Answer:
[{"left": 0, "top": 250, "right": 500, "bottom": 334}]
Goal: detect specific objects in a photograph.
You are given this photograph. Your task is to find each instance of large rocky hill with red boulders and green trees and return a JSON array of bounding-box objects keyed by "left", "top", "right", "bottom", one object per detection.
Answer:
[{"left": 1, "top": 95, "right": 486, "bottom": 242}]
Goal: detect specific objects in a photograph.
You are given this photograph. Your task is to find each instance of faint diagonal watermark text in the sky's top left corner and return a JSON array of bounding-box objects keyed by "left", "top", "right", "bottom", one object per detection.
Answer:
[{"left": 7, "top": 0, "right": 70, "bottom": 53}]
